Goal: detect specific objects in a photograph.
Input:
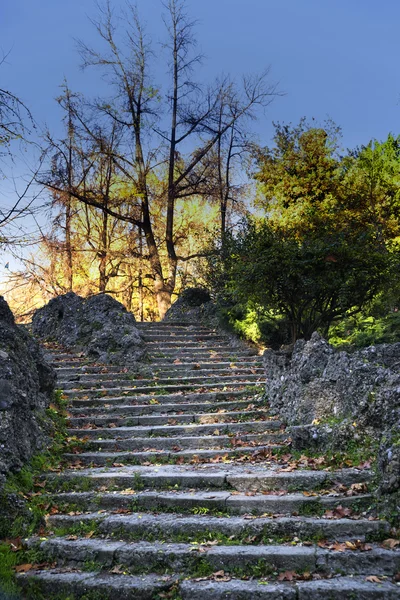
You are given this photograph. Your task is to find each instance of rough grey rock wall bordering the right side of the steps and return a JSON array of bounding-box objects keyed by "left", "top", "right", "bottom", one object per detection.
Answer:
[{"left": 264, "top": 333, "right": 400, "bottom": 506}]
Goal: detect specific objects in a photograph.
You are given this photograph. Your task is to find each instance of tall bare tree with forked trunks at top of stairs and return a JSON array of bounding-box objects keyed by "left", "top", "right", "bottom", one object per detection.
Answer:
[{"left": 40, "top": 0, "right": 276, "bottom": 318}]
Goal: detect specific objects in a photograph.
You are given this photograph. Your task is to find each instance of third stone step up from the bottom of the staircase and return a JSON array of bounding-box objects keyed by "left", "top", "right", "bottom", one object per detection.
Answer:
[{"left": 47, "top": 512, "right": 390, "bottom": 545}]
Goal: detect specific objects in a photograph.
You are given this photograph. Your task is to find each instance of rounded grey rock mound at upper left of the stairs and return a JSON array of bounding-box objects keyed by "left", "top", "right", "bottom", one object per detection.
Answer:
[{"left": 32, "top": 292, "right": 146, "bottom": 366}]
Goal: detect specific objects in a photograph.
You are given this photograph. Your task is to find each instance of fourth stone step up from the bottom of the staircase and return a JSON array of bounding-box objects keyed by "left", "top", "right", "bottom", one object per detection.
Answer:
[{"left": 53, "top": 490, "right": 374, "bottom": 516}]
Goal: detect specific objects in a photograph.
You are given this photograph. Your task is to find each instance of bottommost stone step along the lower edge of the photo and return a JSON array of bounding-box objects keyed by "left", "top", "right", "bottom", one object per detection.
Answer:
[{"left": 18, "top": 569, "right": 399, "bottom": 600}]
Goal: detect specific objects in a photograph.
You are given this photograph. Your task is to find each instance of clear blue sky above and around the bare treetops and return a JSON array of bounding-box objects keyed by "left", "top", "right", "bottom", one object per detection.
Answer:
[{"left": 0, "top": 0, "right": 400, "bottom": 147}]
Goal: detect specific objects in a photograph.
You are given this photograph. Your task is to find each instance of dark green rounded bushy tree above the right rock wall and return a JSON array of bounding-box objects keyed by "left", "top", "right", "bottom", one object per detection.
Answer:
[{"left": 220, "top": 220, "right": 394, "bottom": 342}]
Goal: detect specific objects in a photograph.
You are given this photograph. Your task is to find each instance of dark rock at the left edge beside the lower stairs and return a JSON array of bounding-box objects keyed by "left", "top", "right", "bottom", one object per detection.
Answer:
[{"left": 0, "top": 296, "right": 56, "bottom": 489}]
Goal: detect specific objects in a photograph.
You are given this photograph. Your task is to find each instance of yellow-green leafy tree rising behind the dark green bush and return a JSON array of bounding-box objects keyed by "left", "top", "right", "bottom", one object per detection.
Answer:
[{"left": 255, "top": 118, "right": 344, "bottom": 238}]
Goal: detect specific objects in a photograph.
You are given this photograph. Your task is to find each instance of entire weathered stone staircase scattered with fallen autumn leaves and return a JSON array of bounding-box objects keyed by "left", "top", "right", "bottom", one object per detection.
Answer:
[{"left": 19, "top": 323, "right": 400, "bottom": 600}]
